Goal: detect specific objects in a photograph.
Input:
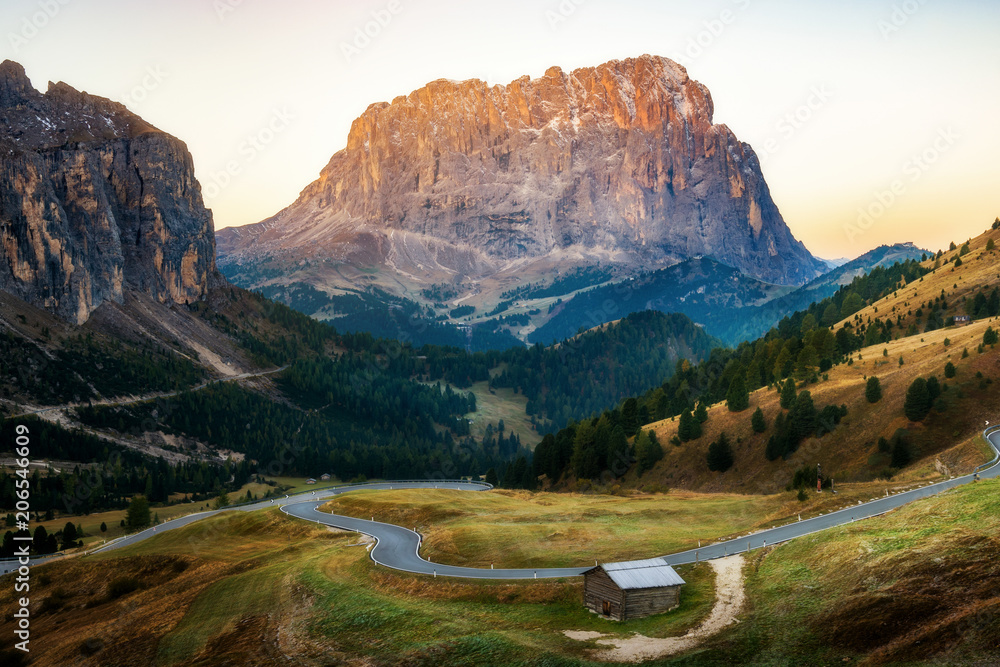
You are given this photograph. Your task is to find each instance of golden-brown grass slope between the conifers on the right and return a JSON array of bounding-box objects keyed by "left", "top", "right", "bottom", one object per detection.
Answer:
[{"left": 623, "top": 224, "right": 1000, "bottom": 493}]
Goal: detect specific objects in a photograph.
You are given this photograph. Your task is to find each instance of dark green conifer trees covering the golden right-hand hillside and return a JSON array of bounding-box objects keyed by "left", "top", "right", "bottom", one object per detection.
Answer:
[{"left": 534, "top": 253, "right": 930, "bottom": 482}]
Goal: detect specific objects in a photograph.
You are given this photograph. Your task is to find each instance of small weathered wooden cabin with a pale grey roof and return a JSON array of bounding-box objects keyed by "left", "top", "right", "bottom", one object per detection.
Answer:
[{"left": 583, "top": 558, "right": 685, "bottom": 621}]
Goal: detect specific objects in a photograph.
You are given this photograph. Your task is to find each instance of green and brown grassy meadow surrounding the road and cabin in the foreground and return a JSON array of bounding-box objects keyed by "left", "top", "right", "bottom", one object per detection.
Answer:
[{"left": 0, "top": 481, "right": 1000, "bottom": 667}]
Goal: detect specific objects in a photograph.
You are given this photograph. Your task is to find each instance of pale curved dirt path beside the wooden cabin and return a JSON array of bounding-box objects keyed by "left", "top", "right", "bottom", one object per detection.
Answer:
[{"left": 563, "top": 556, "right": 746, "bottom": 662}]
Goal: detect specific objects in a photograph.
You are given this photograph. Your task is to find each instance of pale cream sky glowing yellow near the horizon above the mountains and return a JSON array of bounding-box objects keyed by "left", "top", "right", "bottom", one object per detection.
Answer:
[{"left": 0, "top": 0, "right": 1000, "bottom": 259}]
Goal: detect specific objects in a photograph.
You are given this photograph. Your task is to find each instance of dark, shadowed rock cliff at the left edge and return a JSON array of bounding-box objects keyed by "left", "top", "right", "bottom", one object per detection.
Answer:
[{"left": 0, "top": 61, "right": 215, "bottom": 324}]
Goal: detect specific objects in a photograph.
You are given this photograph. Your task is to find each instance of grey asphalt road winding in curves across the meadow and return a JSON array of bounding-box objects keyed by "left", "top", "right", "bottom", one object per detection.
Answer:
[{"left": 7, "top": 427, "right": 1000, "bottom": 579}]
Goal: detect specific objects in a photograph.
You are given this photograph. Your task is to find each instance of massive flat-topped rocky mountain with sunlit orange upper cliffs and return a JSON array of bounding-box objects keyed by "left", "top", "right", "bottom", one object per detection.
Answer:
[{"left": 219, "top": 56, "right": 825, "bottom": 284}]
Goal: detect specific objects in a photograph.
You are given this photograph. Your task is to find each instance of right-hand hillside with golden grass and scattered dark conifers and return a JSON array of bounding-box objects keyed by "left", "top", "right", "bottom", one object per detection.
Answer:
[{"left": 535, "top": 223, "right": 1000, "bottom": 493}]
